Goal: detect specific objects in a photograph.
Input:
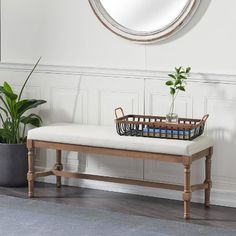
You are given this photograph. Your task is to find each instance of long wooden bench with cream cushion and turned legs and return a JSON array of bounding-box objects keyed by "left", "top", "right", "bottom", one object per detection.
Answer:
[{"left": 27, "top": 123, "right": 213, "bottom": 219}]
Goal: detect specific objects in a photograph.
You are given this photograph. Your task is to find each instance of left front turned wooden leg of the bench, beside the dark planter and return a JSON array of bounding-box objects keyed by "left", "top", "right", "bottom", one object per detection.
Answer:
[{"left": 27, "top": 147, "right": 34, "bottom": 198}]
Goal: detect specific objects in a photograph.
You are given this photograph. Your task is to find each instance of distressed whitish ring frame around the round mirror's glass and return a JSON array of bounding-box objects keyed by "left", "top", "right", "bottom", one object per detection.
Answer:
[{"left": 88, "top": 0, "right": 201, "bottom": 43}]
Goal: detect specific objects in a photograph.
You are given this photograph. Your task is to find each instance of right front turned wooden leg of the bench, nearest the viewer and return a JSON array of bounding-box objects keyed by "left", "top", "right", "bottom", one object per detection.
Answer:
[{"left": 183, "top": 164, "right": 192, "bottom": 219}]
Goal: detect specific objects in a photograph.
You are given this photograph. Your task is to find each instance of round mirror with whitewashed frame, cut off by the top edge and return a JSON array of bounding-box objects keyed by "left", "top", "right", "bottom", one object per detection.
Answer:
[{"left": 89, "top": 0, "right": 200, "bottom": 42}]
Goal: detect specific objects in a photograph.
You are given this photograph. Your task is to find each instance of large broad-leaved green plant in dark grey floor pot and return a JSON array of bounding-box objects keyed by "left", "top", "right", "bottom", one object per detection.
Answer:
[{"left": 0, "top": 59, "right": 46, "bottom": 187}]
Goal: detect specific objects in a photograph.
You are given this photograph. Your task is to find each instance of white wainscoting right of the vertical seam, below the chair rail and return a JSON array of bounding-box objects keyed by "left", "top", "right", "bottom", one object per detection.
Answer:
[{"left": 145, "top": 80, "right": 236, "bottom": 194}]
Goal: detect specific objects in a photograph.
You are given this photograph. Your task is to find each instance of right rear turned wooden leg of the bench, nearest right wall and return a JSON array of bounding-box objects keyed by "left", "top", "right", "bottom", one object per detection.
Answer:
[{"left": 205, "top": 148, "right": 212, "bottom": 207}]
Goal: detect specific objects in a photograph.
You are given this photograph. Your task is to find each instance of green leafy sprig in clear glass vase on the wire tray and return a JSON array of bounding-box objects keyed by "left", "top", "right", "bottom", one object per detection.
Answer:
[{"left": 166, "top": 67, "right": 191, "bottom": 123}]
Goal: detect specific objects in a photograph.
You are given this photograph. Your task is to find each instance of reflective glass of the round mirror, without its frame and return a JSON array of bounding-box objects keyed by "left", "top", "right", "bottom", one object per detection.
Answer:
[{"left": 100, "top": 0, "right": 189, "bottom": 32}]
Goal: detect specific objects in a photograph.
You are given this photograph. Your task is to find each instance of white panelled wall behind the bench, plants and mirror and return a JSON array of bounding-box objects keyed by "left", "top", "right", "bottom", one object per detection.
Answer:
[{"left": 0, "top": 0, "right": 236, "bottom": 206}]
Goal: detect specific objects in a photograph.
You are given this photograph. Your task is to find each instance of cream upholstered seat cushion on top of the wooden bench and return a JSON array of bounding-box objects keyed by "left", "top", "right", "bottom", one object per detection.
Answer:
[{"left": 28, "top": 123, "right": 213, "bottom": 156}]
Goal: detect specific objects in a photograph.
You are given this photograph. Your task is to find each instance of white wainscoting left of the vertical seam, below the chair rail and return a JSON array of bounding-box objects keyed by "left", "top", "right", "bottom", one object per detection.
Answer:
[{"left": 1, "top": 67, "right": 144, "bottom": 178}]
